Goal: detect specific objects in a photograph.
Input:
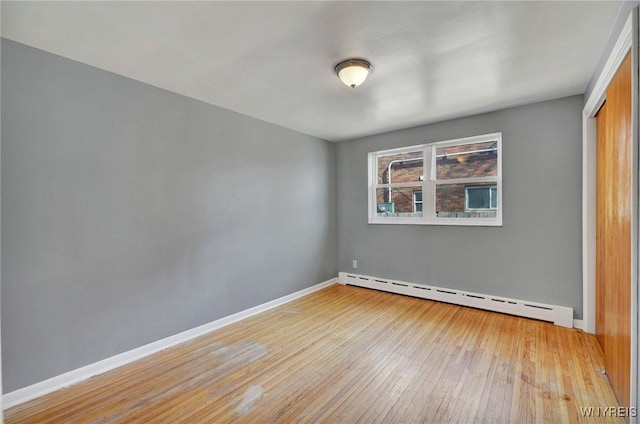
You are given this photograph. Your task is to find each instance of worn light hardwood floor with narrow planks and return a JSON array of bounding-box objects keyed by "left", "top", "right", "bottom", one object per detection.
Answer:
[{"left": 5, "top": 285, "right": 622, "bottom": 423}]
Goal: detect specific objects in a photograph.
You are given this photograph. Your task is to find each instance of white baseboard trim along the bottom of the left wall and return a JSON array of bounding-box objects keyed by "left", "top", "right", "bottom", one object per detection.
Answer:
[{"left": 2, "top": 278, "right": 337, "bottom": 410}]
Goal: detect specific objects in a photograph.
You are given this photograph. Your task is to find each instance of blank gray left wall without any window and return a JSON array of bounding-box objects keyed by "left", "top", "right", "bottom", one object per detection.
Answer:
[{"left": 1, "top": 40, "right": 337, "bottom": 393}]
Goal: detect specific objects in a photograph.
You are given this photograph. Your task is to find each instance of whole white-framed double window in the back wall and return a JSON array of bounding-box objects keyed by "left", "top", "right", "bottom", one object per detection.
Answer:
[{"left": 369, "top": 133, "right": 502, "bottom": 225}]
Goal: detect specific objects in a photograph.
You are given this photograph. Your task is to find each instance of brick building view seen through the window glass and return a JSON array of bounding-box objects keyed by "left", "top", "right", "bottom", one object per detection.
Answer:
[{"left": 376, "top": 141, "right": 498, "bottom": 217}]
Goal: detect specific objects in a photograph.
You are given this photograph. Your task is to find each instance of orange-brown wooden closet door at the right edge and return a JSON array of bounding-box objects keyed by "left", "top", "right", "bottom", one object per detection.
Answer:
[{"left": 596, "top": 53, "right": 632, "bottom": 406}]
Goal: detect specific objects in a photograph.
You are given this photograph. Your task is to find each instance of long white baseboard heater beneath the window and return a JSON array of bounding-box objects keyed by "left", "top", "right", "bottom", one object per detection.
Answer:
[{"left": 338, "top": 272, "right": 573, "bottom": 328}]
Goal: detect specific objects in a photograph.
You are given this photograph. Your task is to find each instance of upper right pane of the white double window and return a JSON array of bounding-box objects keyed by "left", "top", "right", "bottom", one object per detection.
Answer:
[{"left": 436, "top": 141, "right": 498, "bottom": 180}]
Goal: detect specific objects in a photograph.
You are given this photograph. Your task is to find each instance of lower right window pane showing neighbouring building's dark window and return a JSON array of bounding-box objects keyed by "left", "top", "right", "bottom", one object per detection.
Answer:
[{"left": 436, "top": 183, "right": 497, "bottom": 218}]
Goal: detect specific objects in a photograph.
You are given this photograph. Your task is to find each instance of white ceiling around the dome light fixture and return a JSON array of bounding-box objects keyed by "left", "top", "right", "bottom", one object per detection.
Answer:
[{"left": 2, "top": 1, "right": 622, "bottom": 141}]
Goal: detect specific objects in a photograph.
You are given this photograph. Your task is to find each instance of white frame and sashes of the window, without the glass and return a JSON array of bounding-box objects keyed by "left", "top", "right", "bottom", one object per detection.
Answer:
[{"left": 368, "top": 132, "right": 502, "bottom": 226}]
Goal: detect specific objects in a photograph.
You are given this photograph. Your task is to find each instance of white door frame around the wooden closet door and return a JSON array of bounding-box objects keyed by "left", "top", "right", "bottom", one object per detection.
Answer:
[{"left": 578, "top": 8, "right": 640, "bottom": 412}]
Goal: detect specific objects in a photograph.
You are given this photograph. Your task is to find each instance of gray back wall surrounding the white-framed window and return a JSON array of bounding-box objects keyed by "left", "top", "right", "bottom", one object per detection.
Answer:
[{"left": 337, "top": 96, "right": 583, "bottom": 318}]
